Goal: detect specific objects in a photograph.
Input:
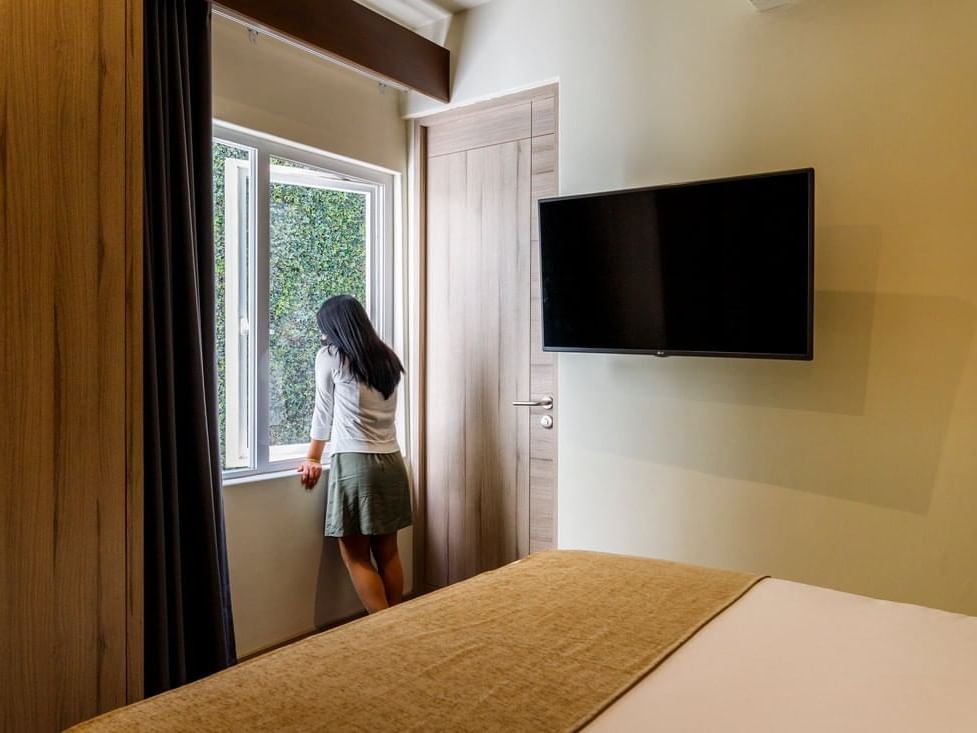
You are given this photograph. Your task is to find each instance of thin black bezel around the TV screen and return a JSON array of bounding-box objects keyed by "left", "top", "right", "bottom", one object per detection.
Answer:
[{"left": 536, "top": 167, "right": 814, "bottom": 361}]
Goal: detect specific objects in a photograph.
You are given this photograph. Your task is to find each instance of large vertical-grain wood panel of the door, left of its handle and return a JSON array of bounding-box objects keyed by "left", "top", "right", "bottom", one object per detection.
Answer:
[{"left": 426, "top": 140, "right": 532, "bottom": 586}]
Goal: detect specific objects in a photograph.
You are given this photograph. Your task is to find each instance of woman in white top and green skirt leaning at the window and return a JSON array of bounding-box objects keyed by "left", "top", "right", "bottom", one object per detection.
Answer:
[{"left": 298, "top": 295, "right": 411, "bottom": 613}]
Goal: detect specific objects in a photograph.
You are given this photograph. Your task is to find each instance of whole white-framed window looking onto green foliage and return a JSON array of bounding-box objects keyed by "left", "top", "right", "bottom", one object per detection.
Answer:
[{"left": 213, "top": 124, "right": 395, "bottom": 478}]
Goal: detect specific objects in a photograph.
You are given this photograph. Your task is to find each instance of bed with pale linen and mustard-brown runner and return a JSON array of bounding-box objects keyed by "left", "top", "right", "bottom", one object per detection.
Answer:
[{"left": 71, "top": 550, "right": 977, "bottom": 733}]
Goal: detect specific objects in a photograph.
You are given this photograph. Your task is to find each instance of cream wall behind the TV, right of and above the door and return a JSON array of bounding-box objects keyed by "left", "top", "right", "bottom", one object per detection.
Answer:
[{"left": 408, "top": 0, "right": 977, "bottom": 614}]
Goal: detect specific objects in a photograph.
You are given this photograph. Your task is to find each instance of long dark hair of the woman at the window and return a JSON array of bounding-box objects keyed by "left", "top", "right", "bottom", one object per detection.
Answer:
[{"left": 316, "top": 295, "right": 404, "bottom": 399}]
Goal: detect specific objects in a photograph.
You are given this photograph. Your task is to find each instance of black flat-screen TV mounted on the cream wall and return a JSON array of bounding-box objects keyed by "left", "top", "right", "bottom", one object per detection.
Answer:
[{"left": 539, "top": 169, "right": 814, "bottom": 359}]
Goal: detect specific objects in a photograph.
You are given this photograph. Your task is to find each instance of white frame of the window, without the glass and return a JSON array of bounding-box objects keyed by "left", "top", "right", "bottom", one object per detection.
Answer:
[{"left": 213, "top": 120, "right": 398, "bottom": 480}]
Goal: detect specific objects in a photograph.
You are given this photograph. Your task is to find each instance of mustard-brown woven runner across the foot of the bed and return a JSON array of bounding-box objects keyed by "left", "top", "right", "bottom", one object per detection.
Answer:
[{"left": 71, "top": 550, "right": 760, "bottom": 733}]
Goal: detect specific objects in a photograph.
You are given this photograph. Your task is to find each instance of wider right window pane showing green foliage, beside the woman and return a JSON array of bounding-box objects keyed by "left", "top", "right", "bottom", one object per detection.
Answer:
[{"left": 268, "top": 158, "right": 371, "bottom": 454}]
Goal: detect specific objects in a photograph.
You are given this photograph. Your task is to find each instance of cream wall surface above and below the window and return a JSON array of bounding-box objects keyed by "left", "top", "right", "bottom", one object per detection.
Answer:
[{"left": 213, "top": 17, "right": 412, "bottom": 656}]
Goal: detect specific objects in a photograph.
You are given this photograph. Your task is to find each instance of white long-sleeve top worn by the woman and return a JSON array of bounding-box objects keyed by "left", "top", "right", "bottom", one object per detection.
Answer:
[{"left": 311, "top": 346, "right": 400, "bottom": 455}]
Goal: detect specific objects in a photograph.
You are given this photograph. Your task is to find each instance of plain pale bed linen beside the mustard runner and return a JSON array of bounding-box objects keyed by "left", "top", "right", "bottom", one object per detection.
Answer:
[{"left": 585, "top": 579, "right": 977, "bottom": 733}]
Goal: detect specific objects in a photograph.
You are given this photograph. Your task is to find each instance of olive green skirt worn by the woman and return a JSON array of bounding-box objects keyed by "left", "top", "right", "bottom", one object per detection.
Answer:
[{"left": 325, "top": 453, "right": 413, "bottom": 537}]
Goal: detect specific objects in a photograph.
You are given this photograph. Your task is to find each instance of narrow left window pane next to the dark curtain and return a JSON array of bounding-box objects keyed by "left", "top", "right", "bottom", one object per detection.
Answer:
[{"left": 213, "top": 140, "right": 254, "bottom": 469}]
